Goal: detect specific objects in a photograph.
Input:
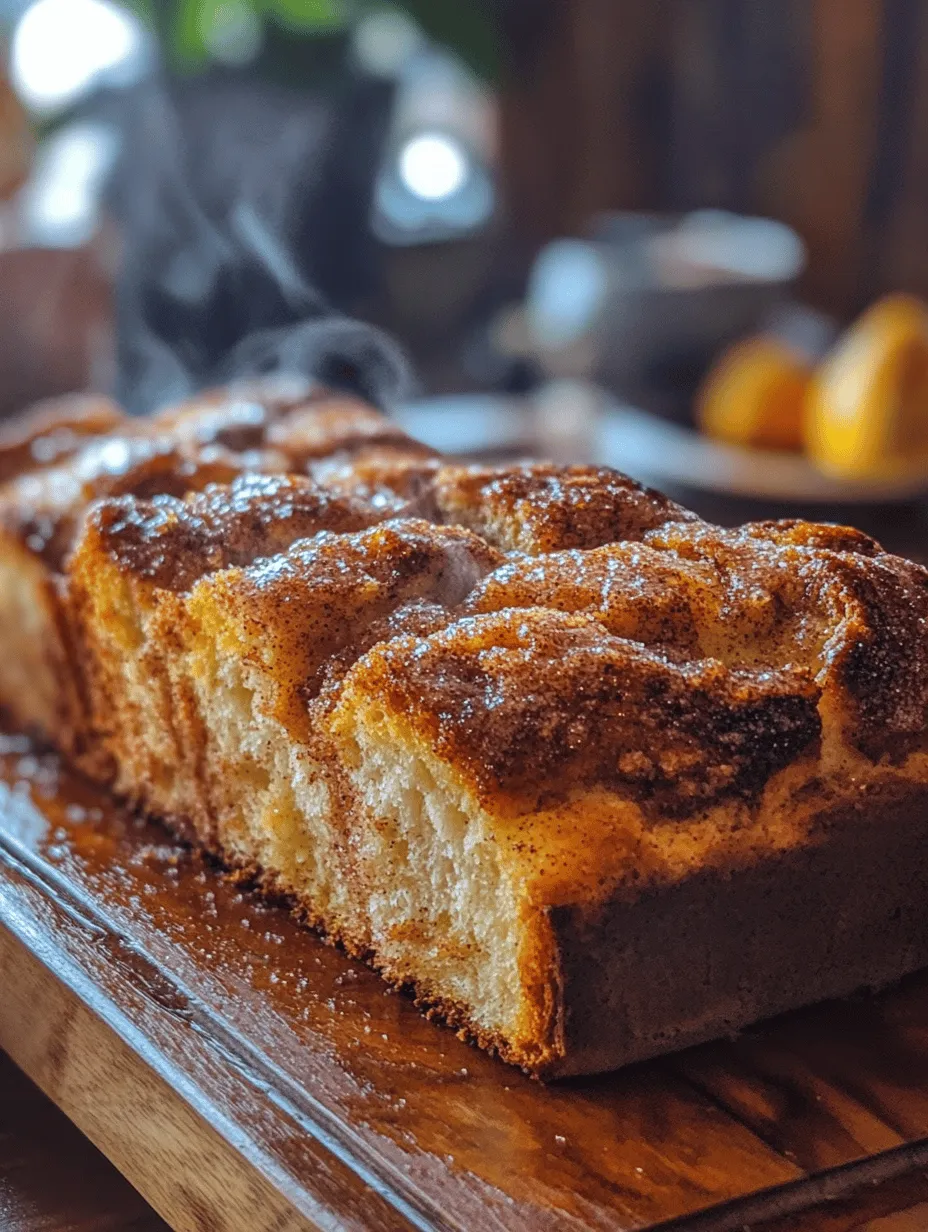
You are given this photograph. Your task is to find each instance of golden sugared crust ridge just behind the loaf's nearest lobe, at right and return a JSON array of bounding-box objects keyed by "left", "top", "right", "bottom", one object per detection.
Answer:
[{"left": 466, "top": 510, "right": 928, "bottom": 760}]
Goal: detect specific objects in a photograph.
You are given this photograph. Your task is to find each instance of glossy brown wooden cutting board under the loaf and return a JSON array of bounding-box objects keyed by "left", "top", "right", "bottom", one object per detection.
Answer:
[{"left": 0, "top": 737, "right": 928, "bottom": 1232}]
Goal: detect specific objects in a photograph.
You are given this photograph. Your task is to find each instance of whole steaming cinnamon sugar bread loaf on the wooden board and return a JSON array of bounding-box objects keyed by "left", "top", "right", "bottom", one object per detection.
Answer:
[{"left": 0, "top": 391, "right": 928, "bottom": 1076}]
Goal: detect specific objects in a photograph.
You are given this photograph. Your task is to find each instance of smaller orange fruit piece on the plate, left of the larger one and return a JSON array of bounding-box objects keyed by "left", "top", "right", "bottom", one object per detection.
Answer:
[{"left": 696, "top": 335, "right": 812, "bottom": 450}]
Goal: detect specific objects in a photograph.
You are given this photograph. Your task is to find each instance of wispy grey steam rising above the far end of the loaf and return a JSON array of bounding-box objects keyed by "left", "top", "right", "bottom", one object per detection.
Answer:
[{"left": 110, "top": 90, "right": 408, "bottom": 413}]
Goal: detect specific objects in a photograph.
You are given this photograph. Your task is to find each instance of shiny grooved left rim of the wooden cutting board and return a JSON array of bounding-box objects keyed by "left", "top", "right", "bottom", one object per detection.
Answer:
[{"left": 0, "top": 835, "right": 448, "bottom": 1232}]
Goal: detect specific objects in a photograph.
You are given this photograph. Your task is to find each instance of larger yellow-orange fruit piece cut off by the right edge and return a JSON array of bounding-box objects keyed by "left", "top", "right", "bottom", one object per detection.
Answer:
[{"left": 805, "top": 294, "right": 928, "bottom": 479}]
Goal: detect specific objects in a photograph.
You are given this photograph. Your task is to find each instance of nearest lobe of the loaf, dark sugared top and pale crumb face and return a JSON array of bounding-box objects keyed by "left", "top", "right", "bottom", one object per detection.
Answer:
[{"left": 330, "top": 609, "right": 818, "bottom": 1073}]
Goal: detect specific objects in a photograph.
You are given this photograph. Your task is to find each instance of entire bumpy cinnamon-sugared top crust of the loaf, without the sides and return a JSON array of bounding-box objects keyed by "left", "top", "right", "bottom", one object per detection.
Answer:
[{"left": 10, "top": 376, "right": 928, "bottom": 817}]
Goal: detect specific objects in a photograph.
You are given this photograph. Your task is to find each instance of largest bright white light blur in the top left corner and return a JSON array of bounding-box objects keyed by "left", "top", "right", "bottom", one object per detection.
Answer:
[{"left": 10, "top": 0, "right": 143, "bottom": 111}]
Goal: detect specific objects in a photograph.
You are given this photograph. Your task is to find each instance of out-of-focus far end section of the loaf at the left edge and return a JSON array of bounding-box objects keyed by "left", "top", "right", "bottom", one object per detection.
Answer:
[{"left": 0, "top": 381, "right": 429, "bottom": 756}]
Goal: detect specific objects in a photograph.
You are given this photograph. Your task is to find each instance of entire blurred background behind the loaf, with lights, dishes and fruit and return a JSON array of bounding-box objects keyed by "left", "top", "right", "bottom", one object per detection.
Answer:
[{"left": 0, "top": 0, "right": 928, "bottom": 544}]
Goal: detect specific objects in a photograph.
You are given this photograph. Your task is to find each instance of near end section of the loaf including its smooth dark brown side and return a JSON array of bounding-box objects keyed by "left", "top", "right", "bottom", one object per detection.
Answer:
[{"left": 332, "top": 525, "right": 928, "bottom": 1076}]
